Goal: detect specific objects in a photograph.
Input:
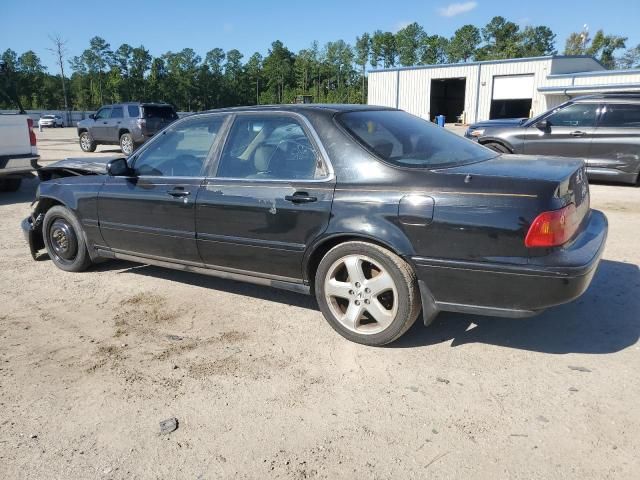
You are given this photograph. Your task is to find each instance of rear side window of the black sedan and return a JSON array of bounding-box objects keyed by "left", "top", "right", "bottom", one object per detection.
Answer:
[{"left": 217, "top": 114, "right": 327, "bottom": 180}]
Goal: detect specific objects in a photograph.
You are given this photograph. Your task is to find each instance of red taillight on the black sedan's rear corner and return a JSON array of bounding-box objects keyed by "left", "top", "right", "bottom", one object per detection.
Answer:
[{"left": 524, "top": 203, "right": 580, "bottom": 247}]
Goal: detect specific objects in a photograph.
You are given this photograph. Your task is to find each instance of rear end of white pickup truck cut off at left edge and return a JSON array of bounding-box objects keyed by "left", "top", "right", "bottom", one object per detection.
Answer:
[{"left": 0, "top": 114, "right": 39, "bottom": 192}]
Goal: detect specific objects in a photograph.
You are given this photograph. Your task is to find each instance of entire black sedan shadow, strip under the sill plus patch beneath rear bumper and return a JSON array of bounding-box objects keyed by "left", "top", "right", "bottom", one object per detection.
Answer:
[{"left": 94, "top": 260, "right": 640, "bottom": 354}]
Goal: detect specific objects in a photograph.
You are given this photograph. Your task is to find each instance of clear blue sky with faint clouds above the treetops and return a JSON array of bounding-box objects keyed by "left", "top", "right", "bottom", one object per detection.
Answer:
[{"left": 0, "top": 0, "right": 640, "bottom": 73}]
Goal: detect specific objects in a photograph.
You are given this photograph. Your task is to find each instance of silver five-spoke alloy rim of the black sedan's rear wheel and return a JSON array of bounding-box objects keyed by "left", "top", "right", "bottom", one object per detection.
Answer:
[{"left": 324, "top": 255, "right": 398, "bottom": 335}]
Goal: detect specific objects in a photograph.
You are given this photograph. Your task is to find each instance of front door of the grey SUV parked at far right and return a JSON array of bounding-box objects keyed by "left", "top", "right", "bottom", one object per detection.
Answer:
[{"left": 523, "top": 102, "right": 600, "bottom": 159}]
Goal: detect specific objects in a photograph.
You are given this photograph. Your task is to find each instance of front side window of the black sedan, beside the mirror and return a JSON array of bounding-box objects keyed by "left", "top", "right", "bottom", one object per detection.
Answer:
[{"left": 133, "top": 116, "right": 224, "bottom": 177}]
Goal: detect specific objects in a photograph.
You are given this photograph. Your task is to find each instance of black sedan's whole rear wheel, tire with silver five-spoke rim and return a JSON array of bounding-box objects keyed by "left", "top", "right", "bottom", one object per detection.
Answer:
[{"left": 315, "top": 242, "right": 420, "bottom": 346}]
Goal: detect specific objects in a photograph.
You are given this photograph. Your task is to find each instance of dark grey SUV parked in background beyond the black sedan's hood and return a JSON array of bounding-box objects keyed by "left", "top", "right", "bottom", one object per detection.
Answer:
[{"left": 78, "top": 103, "right": 178, "bottom": 155}]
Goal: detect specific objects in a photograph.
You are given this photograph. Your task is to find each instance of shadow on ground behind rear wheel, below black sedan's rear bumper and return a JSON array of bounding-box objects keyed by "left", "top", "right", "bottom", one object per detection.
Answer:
[{"left": 390, "top": 260, "right": 640, "bottom": 354}]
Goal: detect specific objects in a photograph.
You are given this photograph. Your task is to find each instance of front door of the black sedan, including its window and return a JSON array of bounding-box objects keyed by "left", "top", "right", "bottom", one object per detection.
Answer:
[{"left": 98, "top": 115, "right": 225, "bottom": 264}]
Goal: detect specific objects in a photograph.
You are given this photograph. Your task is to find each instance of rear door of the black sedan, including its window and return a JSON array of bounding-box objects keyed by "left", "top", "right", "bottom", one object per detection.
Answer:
[{"left": 196, "top": 112, "right": 335, "bottom": 281}]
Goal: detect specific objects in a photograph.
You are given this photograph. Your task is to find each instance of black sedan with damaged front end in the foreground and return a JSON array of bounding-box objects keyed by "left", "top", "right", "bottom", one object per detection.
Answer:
[{"left": 22, "top": 105, "right": 607, "bottom": 345}]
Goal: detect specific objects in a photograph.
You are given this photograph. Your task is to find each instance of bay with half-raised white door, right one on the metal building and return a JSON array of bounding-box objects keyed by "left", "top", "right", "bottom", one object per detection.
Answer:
[{"left": 489, "top": 75, "right": 533, "bottom": 119}]
